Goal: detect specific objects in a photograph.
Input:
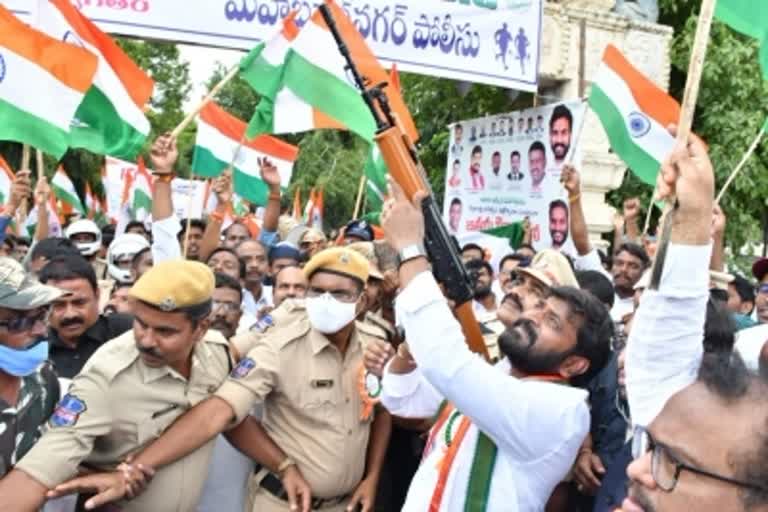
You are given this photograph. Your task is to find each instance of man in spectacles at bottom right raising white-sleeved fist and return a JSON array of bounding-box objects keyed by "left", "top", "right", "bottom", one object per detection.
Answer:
[{"left": 623, "top": 128, "right": 768, "bottom": 512}]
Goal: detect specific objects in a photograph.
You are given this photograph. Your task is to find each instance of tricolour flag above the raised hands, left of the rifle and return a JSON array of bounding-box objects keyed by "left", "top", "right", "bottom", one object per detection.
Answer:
[{"left": 192, "top": 102, "right": 299, "bottom": 205}]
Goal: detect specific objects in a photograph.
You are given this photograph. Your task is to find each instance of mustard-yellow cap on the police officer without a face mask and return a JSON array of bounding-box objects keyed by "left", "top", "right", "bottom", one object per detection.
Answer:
[{"left": 128, "top": 260, "right": 215, "bottom": 312}]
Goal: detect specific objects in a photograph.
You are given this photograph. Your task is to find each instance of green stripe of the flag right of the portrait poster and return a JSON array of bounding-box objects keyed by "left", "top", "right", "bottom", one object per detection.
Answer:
[{"left": 589, "top": 84, "right": 661, "bottom": 186}]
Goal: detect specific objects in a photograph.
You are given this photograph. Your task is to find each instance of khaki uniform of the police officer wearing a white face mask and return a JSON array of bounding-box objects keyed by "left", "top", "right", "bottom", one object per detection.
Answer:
[{"left": 216, "top": 249, "right": 388, "bottom": 512}]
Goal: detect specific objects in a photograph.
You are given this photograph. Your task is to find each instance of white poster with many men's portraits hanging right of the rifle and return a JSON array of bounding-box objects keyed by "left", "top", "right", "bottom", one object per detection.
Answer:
[{"left": 443, "top": 101, "right": 585, "bottom": 253}]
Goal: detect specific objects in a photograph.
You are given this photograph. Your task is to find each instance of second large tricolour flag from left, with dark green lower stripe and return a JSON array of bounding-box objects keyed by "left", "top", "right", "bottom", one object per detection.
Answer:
[{"left": 35, "top": 0, "right": 154, "bottom": 160}]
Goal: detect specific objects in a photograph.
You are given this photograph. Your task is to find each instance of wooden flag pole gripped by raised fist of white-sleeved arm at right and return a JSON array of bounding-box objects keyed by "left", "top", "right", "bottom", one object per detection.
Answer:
[{"left": 648, "top": 0, "right": 717, "bottom": 290}]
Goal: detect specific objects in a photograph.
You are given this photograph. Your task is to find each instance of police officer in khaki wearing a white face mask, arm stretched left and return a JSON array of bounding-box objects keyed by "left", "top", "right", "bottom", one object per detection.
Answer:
[{"left": 98, "top": 248, "right": 391, "bottom": 512}]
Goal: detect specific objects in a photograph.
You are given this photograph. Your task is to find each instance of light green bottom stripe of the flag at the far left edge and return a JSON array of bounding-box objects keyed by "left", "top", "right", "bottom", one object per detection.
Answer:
[{"left": 0, "top": 99, "right": 69, "bottom": 159}]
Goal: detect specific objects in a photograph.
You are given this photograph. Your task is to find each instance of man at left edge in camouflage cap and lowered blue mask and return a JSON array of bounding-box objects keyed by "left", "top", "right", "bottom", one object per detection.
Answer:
[{"left": 0, "top": 258, "right": 62, "bottom": 477}]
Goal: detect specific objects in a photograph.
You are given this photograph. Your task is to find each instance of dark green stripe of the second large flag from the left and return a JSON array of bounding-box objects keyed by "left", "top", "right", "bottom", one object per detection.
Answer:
[{"left": 70, "top": 86, "right": 147, "bottom": 160}]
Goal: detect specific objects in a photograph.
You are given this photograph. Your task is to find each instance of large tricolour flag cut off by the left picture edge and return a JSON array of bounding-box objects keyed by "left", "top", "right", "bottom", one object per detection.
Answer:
[{"left": 0, "top": 5, "right": 97, "bottom": 158}]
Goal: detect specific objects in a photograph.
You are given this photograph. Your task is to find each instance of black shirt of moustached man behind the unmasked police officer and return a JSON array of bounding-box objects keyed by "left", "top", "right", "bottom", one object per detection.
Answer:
[{"left": 48, "top": 313, "right": 133, "bottom": 379}]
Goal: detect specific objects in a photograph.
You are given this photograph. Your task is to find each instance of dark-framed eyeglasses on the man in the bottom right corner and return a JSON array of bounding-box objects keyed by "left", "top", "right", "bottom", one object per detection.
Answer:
[{"left": 632, "top": 426, "right": 768, "bottom": 492}]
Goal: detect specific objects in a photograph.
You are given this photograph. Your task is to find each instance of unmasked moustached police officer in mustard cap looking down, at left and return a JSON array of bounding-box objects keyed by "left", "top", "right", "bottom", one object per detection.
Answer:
[{"left": 0, "top": 260, "right": 231, "bottom": 512}]
